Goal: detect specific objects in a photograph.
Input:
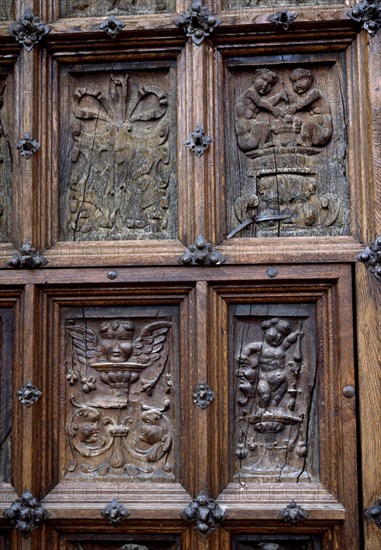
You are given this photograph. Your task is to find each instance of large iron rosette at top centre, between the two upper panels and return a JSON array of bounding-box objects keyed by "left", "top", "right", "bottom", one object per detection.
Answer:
[{"left": 176, "top": 2, "right": 221, "bottom": 46}]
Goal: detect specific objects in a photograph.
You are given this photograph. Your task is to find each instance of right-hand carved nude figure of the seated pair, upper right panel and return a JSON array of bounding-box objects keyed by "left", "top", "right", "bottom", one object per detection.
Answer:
[{"left": 284, "top": 68, "right": 333, "bottom": 147}]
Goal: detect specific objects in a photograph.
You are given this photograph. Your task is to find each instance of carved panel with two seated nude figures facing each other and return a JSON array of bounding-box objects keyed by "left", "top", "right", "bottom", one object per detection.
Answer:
[{"left": 226, "top": 56, "right": 349, "bottom": 237}]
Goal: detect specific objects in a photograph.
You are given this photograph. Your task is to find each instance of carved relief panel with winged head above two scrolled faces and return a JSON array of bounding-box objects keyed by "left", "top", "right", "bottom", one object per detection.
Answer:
[{"left": 65, "top": 312, "right": 174, "bottom": 481}]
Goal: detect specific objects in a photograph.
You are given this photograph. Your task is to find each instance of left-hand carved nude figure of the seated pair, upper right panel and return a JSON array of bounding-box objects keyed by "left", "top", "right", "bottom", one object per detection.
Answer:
[{"left": 236, "top": 69, "right": 288, "bottom": 152}]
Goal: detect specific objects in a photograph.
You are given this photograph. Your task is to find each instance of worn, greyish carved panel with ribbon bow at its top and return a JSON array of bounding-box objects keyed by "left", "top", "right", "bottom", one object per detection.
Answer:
[{"left": 60, "top": 69, "right": 177, "bottom": 240}]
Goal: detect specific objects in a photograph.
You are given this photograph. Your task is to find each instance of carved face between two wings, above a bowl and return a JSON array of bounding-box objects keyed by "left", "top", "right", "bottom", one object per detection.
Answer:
[{"left": 98, "top": 321, "right": 134, "bottom": 363}]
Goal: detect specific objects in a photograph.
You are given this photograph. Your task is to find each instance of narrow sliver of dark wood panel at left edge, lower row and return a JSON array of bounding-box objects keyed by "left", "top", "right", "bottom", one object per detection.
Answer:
[{"left": 0, "top": 308, "right": 13, "bottom": 483}]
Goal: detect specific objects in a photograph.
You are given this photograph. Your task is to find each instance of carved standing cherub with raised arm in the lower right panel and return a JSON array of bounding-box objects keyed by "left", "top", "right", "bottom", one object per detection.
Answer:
[{"left": 238, "top": 317, "right": 302, "bottom": 409}]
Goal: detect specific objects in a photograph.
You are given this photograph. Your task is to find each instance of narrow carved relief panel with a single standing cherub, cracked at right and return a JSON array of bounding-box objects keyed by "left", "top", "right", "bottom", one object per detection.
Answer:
[{"left": 231, "top": 305, "right": 318, "bottom": 481}]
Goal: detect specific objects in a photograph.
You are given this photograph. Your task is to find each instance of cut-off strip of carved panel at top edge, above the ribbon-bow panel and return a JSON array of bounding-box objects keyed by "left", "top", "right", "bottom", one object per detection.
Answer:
[{"left": 60, "top": 0, "right": 176, "bottom": 17}]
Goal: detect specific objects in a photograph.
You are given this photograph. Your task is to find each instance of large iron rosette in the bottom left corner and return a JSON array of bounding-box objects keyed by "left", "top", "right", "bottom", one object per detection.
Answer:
[{"left": 3, "top": 491, "right": 50, "bottom": 537}]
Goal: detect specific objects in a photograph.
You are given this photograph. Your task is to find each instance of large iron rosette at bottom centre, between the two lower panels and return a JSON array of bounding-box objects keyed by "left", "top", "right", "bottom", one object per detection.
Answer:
[{"left": 181, "top": 492, "right": 228, "bottom": 538}]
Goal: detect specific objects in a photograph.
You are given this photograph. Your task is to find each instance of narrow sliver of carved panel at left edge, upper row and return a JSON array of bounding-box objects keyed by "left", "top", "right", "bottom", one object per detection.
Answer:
[{"left": 0, "top": 73, "right": 14, "bottom": 242}]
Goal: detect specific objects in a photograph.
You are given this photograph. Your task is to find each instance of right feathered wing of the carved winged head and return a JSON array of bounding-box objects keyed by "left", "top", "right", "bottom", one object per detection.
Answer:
[{"left": 129, "top": 321, "right": 172, "bottom": 367}]
